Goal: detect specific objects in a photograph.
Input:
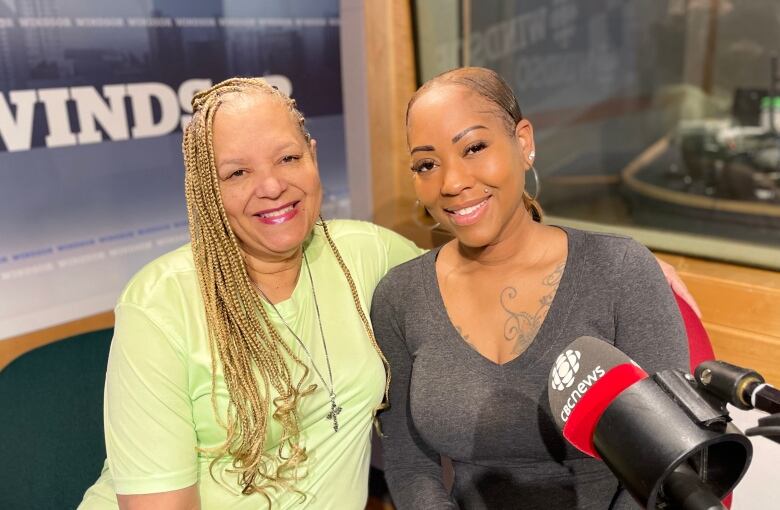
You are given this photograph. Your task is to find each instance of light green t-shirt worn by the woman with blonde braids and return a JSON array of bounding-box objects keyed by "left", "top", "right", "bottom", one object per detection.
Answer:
[{"left": 79, "top": 220, "right": 422, "bottom": 510}]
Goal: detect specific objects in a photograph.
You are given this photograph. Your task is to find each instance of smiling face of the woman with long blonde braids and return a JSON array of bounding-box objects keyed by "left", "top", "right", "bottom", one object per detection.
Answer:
[{"left": 212, "top": 92, "right": 322, "bottom": 261}]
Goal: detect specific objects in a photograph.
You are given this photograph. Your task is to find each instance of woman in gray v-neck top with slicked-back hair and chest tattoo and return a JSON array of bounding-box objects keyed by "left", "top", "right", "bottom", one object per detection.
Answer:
[{"left": 372, "top": 68, "right": 688, "bottom": 510}]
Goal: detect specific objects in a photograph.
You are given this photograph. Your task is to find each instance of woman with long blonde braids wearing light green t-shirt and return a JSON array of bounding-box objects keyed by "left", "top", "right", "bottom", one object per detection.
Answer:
[{"left": 80, "top": 79, "right": 421, "bottom": 510}]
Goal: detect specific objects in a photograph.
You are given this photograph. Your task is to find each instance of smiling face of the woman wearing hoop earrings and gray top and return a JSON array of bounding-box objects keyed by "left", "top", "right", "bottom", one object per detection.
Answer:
[{"left": 407, "top": 84, "right": 534, "bottom": 248}]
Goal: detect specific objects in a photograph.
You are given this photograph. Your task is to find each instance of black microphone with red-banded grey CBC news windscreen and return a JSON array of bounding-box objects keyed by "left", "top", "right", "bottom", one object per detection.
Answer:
[{"left": 548, "top": 336, "right": 752, "bottom": 510}]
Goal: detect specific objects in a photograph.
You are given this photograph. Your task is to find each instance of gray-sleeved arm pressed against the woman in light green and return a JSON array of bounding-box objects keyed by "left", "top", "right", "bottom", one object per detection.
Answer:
[{"left": 371, "top": 278, "right": 457, "bottom": 510}]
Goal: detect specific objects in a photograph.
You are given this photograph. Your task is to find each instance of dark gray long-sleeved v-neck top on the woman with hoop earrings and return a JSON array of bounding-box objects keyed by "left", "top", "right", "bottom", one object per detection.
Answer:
[{"left": 371, "top": 228, "right": 688, "bottom": 510}]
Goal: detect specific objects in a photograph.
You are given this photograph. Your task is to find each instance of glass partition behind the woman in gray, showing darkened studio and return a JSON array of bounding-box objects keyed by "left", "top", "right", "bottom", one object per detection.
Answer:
[{"left": 415, "top": 0, "right": 780, "bottom": 268}]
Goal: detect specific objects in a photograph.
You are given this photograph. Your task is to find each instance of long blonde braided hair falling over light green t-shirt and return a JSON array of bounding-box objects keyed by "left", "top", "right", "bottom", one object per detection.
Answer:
[{"left": 182, "top": 78, "right": 389, "bottom": 505}]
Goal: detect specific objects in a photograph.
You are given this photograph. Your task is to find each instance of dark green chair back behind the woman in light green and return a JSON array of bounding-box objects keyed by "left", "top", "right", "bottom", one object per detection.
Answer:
[{"left": 0, "top": 329, "right": 113, "bottom": 510}]
